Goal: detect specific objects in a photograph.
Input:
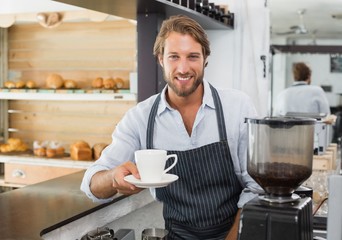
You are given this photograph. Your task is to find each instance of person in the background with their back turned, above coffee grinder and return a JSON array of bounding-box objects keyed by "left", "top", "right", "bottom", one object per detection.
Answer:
[{"left": 273, "top": 62, "right": 330, "bottom": 116}]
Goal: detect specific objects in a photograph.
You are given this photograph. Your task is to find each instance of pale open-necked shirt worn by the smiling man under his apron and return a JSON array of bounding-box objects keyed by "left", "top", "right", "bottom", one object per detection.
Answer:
[{"left": 81, "top": 80, "right": 258, "bottom": 207}]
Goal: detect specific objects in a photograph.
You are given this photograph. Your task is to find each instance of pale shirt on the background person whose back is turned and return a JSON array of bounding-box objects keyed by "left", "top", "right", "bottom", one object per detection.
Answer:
[{"left": 273, "top": 81, "right": 330, "bottom": 116}]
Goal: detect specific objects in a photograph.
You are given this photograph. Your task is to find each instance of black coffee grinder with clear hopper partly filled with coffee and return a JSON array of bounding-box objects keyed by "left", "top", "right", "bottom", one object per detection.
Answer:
[{"left": 239, "top": 117, "right": 316, "bottom": 240}]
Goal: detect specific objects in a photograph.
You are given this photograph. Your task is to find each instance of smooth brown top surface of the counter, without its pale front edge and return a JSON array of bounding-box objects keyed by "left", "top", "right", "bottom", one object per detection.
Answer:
[{"left": 0, "top": 171, "right": 125, "bottom": 240}]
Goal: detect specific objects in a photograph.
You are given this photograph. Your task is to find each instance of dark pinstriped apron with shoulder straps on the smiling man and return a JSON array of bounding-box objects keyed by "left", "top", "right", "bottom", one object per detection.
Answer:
[{"left": 146, "top": 86, "right": 242, "bottom": 240}]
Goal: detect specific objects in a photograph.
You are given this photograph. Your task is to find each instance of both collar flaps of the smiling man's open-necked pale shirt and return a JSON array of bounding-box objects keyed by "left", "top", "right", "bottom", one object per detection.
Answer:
[{"left": 158, "top": 79, "right": 215, "bottom": 115}]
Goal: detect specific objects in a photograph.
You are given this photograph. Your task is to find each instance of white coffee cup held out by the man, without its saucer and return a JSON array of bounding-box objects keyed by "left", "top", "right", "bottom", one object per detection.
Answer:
[{"left": 135, "top": 149, "right": 178, "bottom": 183}]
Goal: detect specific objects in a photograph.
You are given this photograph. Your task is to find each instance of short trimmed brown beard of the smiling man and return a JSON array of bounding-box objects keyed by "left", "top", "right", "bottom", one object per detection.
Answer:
[{"left": 163, "top": 69, "right": 204, "bottom": 97}]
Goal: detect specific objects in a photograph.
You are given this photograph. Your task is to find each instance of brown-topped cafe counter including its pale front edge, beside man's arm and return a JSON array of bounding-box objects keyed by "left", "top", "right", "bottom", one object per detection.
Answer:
[{"left": 0, "top": 171, "right": 154, "bottom": 240}]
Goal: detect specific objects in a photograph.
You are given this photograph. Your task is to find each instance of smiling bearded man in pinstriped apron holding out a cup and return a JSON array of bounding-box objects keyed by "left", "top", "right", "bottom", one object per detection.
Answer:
[{"left": 81, "top": 16, "right": 257, "bottom": 240}]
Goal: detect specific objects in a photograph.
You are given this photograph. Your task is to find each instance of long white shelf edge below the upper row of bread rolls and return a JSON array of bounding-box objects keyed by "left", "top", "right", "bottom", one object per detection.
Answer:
[{"left": 0, "top": 92, "right": 137, "bottom": 101}]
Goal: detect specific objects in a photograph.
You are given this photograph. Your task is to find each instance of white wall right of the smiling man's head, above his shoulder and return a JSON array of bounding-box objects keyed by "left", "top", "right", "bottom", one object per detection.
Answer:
[{"left": 205, "top": 0, "right": 270, "bottom": 116}]
